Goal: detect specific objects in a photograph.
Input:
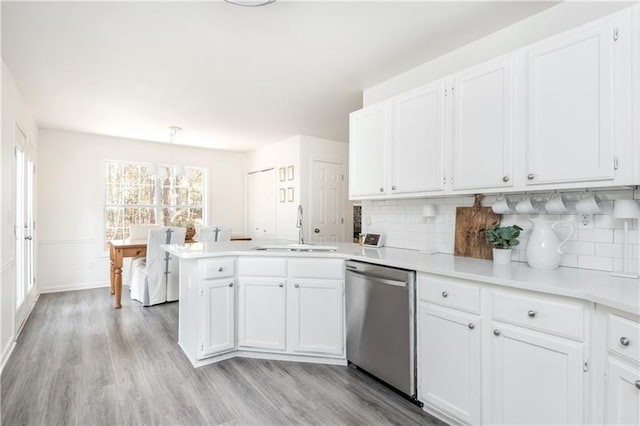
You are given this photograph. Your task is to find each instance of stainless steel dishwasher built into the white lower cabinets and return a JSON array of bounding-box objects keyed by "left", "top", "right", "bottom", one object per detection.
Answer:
[{"left": 346, "top": 260, "right": 417, "bottom": 400}]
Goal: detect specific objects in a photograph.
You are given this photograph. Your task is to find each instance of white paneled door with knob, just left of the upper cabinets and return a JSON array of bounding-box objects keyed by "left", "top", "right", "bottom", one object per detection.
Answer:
[{"left": 309, "top": 160, "right": 344, "bottom": 243}]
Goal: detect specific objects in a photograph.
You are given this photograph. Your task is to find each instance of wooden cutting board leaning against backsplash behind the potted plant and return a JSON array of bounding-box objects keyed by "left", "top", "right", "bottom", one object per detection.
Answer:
[{"left": 453, "top": 194, "right": 500, "bottom": 259}]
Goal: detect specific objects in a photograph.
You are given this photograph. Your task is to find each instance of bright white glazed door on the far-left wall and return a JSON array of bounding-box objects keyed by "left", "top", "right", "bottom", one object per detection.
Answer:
[{"left": 15, "top": 126, "right": 35, "bottom": 329}]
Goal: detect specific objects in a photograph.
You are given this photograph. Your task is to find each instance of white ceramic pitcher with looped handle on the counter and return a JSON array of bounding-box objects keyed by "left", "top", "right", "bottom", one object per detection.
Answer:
[{"left": 526, "top": 218, "right": 575, "bottom": 269}]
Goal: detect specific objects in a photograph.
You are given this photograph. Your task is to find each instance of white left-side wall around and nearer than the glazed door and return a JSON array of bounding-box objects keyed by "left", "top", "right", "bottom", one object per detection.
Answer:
[{"left": 0, "top": 62, "right": 38, "bottom": 367}]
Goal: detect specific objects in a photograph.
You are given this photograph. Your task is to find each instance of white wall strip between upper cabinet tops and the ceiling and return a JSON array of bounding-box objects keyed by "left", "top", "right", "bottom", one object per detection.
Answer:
[{"left": 363, "top": 1, "right": 634, "bottom": 106}]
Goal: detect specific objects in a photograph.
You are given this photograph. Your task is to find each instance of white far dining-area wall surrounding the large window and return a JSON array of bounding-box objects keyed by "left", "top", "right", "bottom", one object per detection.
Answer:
[{"left": 37, "top": 130, "right": 246, "bottom": 297}]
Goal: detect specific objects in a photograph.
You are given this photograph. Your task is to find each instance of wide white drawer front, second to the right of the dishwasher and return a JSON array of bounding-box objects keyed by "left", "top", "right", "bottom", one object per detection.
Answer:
[{"left": 492, "top": 291, "right": 584, "bottom": 340}]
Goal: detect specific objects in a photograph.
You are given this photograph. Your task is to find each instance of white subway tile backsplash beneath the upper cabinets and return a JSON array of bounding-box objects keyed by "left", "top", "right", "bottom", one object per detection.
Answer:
[{"left": 362, "top": 190, "right": 640, "bottom": 271}]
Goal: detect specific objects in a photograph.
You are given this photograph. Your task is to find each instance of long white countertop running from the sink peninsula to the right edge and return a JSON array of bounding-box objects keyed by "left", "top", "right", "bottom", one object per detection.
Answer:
[{"left": 164, "top": 240, "right": 640, "bottom": 315}]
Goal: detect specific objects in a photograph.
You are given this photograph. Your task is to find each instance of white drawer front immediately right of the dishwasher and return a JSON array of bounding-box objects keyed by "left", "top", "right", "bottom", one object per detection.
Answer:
[{"left": 418, "top": 275, "right": 480, "bottom": 314}]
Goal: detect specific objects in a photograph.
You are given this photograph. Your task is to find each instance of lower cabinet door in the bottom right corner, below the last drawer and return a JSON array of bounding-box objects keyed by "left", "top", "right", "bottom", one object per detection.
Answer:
[{"left": 605, "top": 356, "right": 640, "bottom": 425}]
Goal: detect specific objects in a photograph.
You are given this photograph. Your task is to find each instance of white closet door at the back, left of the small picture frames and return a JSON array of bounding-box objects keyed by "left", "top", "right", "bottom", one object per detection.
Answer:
[{"left": 247, "top": 169, "right": 276, "bottom": 238}]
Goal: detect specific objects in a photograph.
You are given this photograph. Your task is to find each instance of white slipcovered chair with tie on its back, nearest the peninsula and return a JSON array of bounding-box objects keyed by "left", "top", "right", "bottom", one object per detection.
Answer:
[{"left": 131, "top": 226, "right": 186, "bottom": 306}]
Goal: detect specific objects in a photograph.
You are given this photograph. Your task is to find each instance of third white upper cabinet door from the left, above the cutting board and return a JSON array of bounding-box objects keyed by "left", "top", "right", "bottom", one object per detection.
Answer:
[{"left": 452, "top": 55, "right": 515, "bottom": 190}]
